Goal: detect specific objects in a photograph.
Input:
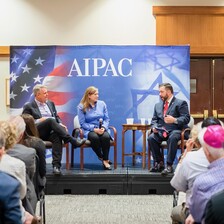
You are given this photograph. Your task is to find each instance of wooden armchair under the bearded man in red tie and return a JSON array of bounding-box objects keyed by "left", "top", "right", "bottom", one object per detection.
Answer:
[{"left": 148, "top": 116, "right": 194, "bottom": 169}]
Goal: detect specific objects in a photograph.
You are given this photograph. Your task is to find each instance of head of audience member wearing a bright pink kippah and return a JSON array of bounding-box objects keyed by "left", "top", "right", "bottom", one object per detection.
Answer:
[{"left": 198, "top": 125, "right": 224, "bottom": 163}]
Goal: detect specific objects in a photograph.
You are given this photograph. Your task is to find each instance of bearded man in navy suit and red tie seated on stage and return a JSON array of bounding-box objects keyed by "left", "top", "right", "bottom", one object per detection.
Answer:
[{"left": 148, "top": 83, "right": 190, "bottom": 175}]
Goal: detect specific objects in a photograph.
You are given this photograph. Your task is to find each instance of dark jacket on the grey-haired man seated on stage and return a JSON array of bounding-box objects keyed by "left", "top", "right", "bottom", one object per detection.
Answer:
[{"left": 22, "top": 100, "right": 62, "bottom": 123}]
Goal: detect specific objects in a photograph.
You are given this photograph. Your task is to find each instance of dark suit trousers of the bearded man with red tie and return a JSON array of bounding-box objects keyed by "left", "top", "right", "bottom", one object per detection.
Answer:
[{"left": 148, "top": 130, "right": 181, "bottom": 165}]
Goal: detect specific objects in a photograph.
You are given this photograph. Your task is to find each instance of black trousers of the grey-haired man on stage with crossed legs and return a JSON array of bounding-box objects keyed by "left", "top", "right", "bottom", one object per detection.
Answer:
[{"left": 37, "top": 118, "right": 71, "bottom": 167}]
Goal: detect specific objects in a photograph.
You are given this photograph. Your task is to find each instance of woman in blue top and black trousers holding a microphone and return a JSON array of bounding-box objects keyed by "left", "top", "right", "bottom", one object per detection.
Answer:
[{"left": 77, "top": 86, "right": 111, "bottom": 170}]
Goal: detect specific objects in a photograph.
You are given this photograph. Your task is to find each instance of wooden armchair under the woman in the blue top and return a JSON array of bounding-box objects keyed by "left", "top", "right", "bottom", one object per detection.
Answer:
[{"left": 71, "top": 116, "right": 117, "bottom": 170}]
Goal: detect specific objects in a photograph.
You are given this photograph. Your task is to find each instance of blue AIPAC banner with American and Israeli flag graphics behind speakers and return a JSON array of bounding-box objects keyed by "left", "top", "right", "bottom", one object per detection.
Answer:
[{"left": 10, "top": 45, "right": 190, "bottom": 164}]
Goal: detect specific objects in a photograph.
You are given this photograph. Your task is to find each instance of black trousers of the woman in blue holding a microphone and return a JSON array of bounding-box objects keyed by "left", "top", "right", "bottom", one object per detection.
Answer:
[{"left": 88, "top": 131, "right": 110, "bottom": 160}]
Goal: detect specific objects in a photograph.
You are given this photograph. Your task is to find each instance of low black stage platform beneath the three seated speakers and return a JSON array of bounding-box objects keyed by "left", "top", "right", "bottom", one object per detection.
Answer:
[{"left": 46, "top": 164, "right": 174, "bottom": 195}]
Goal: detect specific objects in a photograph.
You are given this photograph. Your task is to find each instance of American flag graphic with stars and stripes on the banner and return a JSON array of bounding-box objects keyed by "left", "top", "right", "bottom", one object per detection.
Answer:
[{"left": 10, "top": 46, "right": 74, "bottom": 130}]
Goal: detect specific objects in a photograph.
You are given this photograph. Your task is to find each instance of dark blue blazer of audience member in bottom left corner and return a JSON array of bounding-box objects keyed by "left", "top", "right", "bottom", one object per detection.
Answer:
[{"left": 0, "top": 171, "right": 22, "bottom": 224}]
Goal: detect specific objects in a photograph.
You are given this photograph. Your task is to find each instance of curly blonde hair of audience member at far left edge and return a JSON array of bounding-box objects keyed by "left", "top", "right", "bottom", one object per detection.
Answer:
[{"left": 0, "top": 121, "right": 17, "bottom": 151}]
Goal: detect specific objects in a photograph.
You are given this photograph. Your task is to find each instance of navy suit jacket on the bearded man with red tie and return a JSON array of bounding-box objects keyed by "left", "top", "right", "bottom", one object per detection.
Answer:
[{"left": 151, "top": 97, "right": 190, "bottom": 131}]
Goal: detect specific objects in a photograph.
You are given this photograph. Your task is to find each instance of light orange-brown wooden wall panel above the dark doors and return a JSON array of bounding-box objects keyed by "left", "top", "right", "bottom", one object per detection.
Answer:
[{"left": 153, "top": 6, "right": 224, "bottom": 55}]
